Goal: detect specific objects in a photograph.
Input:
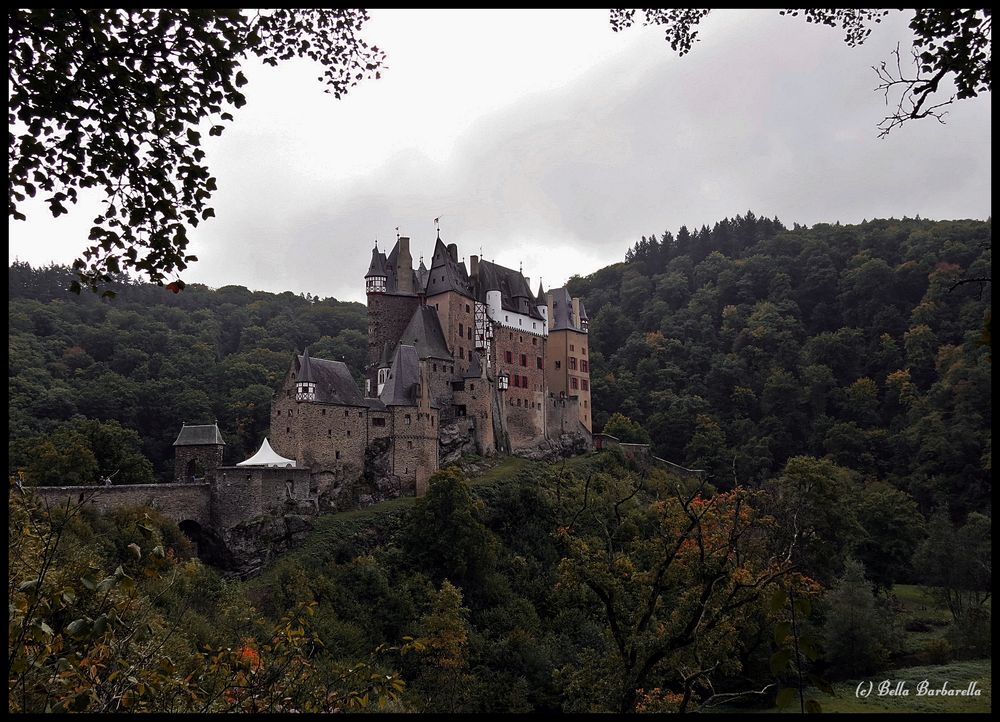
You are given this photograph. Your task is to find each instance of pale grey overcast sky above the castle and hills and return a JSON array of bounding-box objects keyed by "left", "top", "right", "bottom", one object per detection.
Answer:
[{"left": 9, "top": 10, "right": 992, "bottom": 301}]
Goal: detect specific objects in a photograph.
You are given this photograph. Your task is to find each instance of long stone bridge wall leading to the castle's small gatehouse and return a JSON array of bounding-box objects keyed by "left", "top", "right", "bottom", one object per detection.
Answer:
[{"left": 32, "top": 482, "right": 212, "bottom": 528}]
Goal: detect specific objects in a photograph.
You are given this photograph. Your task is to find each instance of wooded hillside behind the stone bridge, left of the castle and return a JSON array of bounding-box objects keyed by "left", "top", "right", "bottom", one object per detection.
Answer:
[{"left": 8, "top": 263, "right": 367, "bottom": 484}]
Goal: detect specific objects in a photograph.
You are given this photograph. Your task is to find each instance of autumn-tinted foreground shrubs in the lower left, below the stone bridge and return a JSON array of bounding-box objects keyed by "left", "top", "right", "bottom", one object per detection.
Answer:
[{"left": 8, "top": 486, "right": 405, "bottom": 713}]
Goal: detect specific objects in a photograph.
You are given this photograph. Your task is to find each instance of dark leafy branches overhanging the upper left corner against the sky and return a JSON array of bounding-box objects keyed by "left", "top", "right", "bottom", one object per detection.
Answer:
[{"left": 7, "top": 8, "right": 384, "bottom": 296}]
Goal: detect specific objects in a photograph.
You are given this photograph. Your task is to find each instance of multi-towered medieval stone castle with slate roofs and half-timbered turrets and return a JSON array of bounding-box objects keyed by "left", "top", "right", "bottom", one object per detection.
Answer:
[{"left": 175, "top": 235, "right": 592, "bottom": 509}]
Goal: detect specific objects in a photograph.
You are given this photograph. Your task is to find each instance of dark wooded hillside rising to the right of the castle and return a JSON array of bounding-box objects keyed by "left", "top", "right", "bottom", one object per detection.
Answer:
[{"left": 569, "top": 212, "right": 992, "bottom": 518}]
